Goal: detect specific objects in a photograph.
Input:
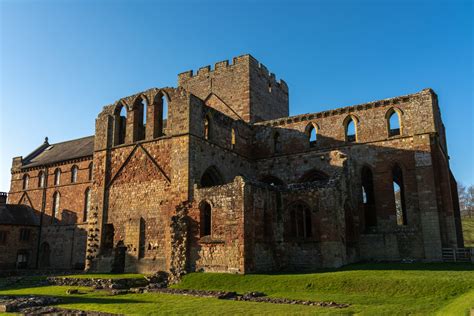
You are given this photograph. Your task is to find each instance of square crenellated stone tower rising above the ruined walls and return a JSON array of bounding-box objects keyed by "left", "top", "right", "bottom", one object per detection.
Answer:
[{"left": 178, "top": 55, "right": 288, "bottom": 123}]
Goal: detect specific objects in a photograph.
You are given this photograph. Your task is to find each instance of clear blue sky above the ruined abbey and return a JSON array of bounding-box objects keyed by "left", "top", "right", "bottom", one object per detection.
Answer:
[{"left": 0, "top": 0, "right": 474, "bottom": 191}]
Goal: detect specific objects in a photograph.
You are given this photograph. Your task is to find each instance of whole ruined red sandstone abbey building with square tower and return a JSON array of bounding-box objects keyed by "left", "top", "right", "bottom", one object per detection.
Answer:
[{"left": 3, "top": 55, "right": 463, "bottom": 274}]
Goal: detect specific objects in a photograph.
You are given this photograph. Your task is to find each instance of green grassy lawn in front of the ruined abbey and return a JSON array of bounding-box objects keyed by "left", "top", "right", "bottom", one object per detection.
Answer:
[{"left": 0, "top": 263, "right": 474, "bottom": 315}]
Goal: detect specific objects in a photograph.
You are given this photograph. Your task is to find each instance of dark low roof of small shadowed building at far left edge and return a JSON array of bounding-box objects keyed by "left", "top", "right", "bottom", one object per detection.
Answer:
[{"left": 0, "top": 204, "right": 39, "bottom": 226}]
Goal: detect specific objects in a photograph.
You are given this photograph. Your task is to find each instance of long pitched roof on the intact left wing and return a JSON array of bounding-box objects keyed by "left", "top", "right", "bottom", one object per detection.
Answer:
[{"left": 22, "top": 136, "right": 94, "bottom": 168}]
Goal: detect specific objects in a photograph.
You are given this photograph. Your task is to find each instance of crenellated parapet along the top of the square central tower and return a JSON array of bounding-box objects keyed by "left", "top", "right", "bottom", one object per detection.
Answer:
[{"left": 178, "top": 54, "right": 288, "bottom": 93}]
